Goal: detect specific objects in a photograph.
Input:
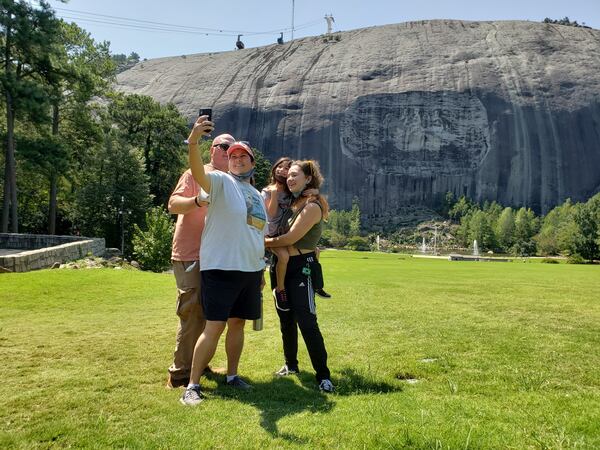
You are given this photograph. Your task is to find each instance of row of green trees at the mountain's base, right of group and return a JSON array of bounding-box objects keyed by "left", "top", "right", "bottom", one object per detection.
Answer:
[{"left": 321, "top": 192, "right": 600, "bottom": 262}]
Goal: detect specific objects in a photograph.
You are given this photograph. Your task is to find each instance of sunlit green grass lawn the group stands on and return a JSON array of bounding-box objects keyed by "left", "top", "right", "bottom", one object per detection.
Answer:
[{"left": 0, "top": 251, "right": 600, "bottom": 449}]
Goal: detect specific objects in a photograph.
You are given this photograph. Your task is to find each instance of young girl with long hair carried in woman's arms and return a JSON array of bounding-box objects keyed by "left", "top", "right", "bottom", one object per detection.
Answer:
[{"left": 261, "top": 157, "right": 331, "bottom": 311}]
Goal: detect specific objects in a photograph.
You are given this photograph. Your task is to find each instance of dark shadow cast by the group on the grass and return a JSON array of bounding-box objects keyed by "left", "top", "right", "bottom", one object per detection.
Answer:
[{"left": 207, "top": 368, "right": 402, "bottom": 444}]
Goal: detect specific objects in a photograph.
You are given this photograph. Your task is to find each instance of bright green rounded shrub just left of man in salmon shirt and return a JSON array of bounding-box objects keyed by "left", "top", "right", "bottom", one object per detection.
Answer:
[{"left": 133, "top": 206, "right": 174, "bottom": 272}]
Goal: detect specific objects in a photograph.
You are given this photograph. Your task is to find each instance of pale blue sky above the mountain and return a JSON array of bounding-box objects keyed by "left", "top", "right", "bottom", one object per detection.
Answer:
[{"left": 39, "top": 0, "right": 600, "bottom": 59}]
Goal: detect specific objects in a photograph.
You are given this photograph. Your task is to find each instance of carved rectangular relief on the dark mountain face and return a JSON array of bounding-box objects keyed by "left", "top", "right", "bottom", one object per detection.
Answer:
[{"left": 340, "top": 92, "right": 490, "bottom": 176}]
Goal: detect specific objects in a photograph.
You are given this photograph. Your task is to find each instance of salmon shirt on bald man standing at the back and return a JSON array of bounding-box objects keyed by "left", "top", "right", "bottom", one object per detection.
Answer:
[{"left": 171, "top": 164, "right": 214, "bottom": 261}]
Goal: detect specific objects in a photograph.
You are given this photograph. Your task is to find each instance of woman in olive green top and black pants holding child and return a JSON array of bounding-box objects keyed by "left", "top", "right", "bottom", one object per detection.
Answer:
[{"left": 265, "top": 161, "right": 334, "bottom": 392}]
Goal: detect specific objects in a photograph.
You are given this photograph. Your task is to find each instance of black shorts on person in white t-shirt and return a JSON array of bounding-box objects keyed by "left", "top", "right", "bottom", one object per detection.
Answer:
[{"left": 200, "top": 270, "right": 263, "bottom": 322}]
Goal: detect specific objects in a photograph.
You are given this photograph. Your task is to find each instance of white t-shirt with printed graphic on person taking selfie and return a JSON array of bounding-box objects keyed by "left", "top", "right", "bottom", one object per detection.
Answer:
[{"left": 200, "top": 171, "right": 267, "bottom": 272}]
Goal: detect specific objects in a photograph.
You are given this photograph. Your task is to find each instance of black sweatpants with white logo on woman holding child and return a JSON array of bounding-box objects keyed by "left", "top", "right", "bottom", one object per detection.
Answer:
[{"left": 270, "top": 252, "right": 331, "bottom": 382}]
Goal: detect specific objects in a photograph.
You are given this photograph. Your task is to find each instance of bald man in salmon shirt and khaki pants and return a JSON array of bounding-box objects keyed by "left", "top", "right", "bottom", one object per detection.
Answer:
[{"left": 167, "top": 134, "right": 235, "bottom": 388}]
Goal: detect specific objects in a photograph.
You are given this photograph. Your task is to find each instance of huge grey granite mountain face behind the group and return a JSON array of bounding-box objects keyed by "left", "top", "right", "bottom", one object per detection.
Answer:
[{"left": 118, "top": 20, "right": 600, "bottom": 224}]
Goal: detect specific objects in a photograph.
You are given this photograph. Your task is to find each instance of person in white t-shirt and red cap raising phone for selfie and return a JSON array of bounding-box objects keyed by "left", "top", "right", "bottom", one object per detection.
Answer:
[{"left": 180, "top": 116, "right": 267, "bottom": 406}]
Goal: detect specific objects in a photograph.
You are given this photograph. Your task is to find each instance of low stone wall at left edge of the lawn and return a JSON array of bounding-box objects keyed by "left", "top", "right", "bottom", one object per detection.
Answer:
[{"left": 0, "top": 233, "right": 106, "bottom": 272}]
